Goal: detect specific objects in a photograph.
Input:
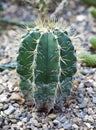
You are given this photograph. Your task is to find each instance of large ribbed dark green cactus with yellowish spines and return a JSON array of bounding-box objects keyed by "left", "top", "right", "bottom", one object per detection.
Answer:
[{"left": 17, "top": 22, "right": 76, "bottom": 110}]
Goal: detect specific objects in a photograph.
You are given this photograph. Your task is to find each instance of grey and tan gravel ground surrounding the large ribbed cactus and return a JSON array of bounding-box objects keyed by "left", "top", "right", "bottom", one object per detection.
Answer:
[{"left": 0, "top": 0, "right": 96, "bottom": 130}]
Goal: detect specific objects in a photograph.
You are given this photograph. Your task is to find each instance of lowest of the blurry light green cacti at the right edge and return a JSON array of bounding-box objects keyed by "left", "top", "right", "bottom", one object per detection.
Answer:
[{"left": 79, "top": 52, "right": 96, "bottom": 67}]
